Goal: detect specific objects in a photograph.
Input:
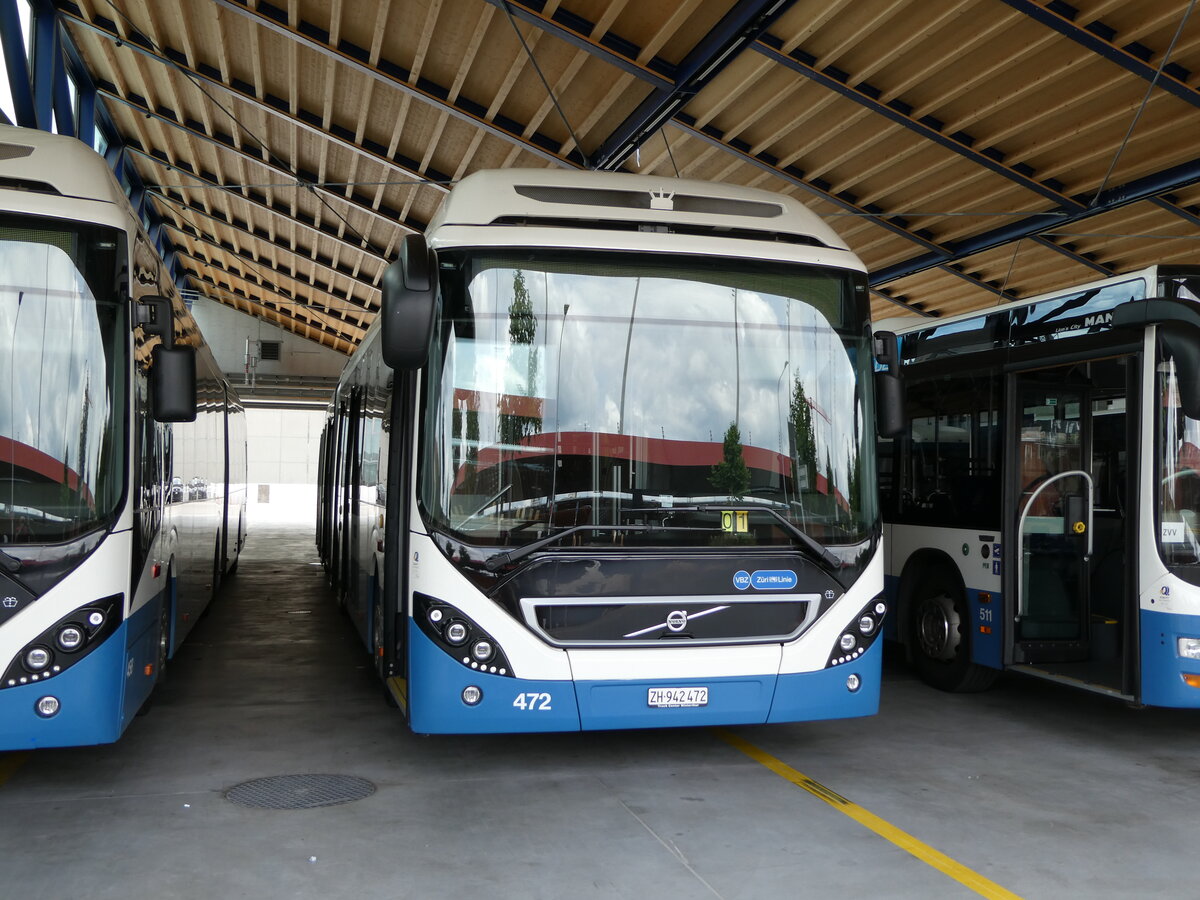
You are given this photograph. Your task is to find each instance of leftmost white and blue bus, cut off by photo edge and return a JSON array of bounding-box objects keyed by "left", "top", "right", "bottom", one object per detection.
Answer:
[{"left": 0, "top": 126, "right": 246, "bottom": 750}]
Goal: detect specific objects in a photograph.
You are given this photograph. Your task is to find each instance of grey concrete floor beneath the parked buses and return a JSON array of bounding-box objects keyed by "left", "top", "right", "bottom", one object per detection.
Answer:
[{"left": 0, "top": 521, "right": 1200, "bottom": 900}]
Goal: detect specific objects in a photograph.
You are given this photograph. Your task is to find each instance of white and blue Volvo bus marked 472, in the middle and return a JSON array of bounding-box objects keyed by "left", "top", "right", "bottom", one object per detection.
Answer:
[{"left": 317, "top": 169, "right": 889, "bottom": 733}]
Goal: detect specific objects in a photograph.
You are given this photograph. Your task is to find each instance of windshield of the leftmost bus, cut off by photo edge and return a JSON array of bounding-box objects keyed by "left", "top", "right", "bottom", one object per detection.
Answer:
[{"left": 0, "top": 216, "right": 128, "bottom": 546}]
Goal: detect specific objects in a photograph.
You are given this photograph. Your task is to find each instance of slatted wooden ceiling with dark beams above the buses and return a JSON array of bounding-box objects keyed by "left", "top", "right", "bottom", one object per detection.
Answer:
[{"left": 55, "top": 0, "right": 1200, "bottom": 352}]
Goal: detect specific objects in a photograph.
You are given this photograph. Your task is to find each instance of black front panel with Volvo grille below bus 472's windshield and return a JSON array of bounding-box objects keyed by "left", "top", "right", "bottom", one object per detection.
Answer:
[{"left": 493, "top": 552, "right": 842, "bottom": 646}]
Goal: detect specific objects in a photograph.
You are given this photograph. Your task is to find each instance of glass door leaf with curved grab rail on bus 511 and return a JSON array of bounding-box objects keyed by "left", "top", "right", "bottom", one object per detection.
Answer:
[{"left": 1009, "top": 370, "right": 1093, "bottom": 664}]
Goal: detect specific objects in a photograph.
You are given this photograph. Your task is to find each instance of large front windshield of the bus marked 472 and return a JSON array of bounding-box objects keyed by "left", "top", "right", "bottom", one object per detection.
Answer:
[{"left": 419, "top": 250, "right": 877, "bottom": 562}]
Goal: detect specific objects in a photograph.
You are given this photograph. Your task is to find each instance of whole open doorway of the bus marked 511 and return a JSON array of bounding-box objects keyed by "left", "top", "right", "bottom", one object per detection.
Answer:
[{"left": 1006, "top": 356, "right": 1138, "bottom": 697}]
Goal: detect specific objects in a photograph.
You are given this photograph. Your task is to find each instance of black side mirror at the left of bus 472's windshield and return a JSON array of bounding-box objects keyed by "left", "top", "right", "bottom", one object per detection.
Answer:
[{"left": 379, "top": 234, "right": 438, "bottom": 370}]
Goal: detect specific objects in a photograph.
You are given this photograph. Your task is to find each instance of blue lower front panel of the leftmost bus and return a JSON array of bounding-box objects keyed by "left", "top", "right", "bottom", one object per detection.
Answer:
[{"left": 0, "top": 623, "right": 128, "bottom": 750}]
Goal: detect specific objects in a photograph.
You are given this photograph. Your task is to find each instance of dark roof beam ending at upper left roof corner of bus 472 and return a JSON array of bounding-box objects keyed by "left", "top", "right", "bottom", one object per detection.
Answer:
[{"left": 60, "top": 5, "right": 450, "bottom": 193}]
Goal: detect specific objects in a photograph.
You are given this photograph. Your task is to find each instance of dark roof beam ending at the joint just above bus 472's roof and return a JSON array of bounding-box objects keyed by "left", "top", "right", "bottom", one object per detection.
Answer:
[{"left": 208, "top": 0, "right": 583, "bottom": 168}]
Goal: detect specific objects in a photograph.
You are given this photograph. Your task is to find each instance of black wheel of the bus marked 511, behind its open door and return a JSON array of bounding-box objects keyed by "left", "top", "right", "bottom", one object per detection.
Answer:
[{"left": 908, "top": 571, "right": 1000, "bottom": 694}]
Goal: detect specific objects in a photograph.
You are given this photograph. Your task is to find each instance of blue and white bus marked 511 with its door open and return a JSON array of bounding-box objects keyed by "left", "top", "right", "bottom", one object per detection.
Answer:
[{"left": 880, "top": 266, "right": 1200, "bottom": 707}]
